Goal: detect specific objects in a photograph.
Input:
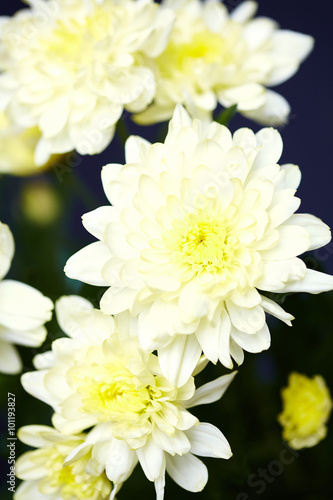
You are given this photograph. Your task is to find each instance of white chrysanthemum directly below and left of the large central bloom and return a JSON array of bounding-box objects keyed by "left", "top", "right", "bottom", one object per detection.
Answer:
[{"left": 22, "top": 296, "right": 234, "bottom": 499}]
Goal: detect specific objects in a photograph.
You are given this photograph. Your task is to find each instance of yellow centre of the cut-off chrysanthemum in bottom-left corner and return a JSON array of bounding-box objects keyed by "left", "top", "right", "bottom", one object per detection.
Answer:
[{"left": 38, "top": 448, "right": 111, "bottom": 500}]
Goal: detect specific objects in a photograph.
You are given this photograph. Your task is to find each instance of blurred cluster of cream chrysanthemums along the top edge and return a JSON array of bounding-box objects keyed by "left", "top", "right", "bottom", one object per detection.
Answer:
[{"left": 0, "top": 0, "right": 313, "bottom": 173}]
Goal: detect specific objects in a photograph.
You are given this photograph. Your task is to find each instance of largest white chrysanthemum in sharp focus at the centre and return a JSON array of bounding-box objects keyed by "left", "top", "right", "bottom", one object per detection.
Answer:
[{"left": 65, "top": 107, "right": 333, "bottom": 385}]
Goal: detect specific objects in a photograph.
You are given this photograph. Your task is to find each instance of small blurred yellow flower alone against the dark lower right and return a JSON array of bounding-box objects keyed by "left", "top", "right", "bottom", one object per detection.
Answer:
[{"left": 278, "top": 373, "right": 332, "bottom": 449}]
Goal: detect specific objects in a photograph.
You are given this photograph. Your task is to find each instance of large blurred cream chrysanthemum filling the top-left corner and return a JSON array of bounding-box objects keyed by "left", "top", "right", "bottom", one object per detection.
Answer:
[{"left": 0, "top": 0, "right": 173, "bottom": 165}]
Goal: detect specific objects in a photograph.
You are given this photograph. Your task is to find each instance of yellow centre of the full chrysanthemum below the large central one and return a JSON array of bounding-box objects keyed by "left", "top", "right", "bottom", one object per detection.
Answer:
[{"left": 67, "top": 339, "right": 183, "bottom": 449}]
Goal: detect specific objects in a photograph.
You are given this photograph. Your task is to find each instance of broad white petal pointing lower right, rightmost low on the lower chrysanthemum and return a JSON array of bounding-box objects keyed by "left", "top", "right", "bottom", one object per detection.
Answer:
[{"left": 186, "top": 423, "right": 232, "bottom": 459}]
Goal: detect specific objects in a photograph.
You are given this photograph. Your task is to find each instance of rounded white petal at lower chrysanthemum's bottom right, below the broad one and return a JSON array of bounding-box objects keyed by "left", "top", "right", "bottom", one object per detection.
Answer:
[{"left": 166, "top": 453, "right": 208, "bottom": 493}]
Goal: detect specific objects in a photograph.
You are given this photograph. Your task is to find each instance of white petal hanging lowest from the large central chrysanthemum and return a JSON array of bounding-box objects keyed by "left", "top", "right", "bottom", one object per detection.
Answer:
[{"left": 158, "top": 334, "right": 201, "bottom": 387}]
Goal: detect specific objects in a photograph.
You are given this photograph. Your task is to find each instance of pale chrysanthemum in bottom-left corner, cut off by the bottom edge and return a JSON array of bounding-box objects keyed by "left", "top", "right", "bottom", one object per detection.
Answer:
[{"left": 13, "top": 425, "right": 111, "bottom": 500}]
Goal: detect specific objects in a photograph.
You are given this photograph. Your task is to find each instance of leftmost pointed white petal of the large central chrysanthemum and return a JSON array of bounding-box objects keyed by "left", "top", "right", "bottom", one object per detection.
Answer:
[{"left": 64, "top": 241, "right": 111, "bottom": 286}]
